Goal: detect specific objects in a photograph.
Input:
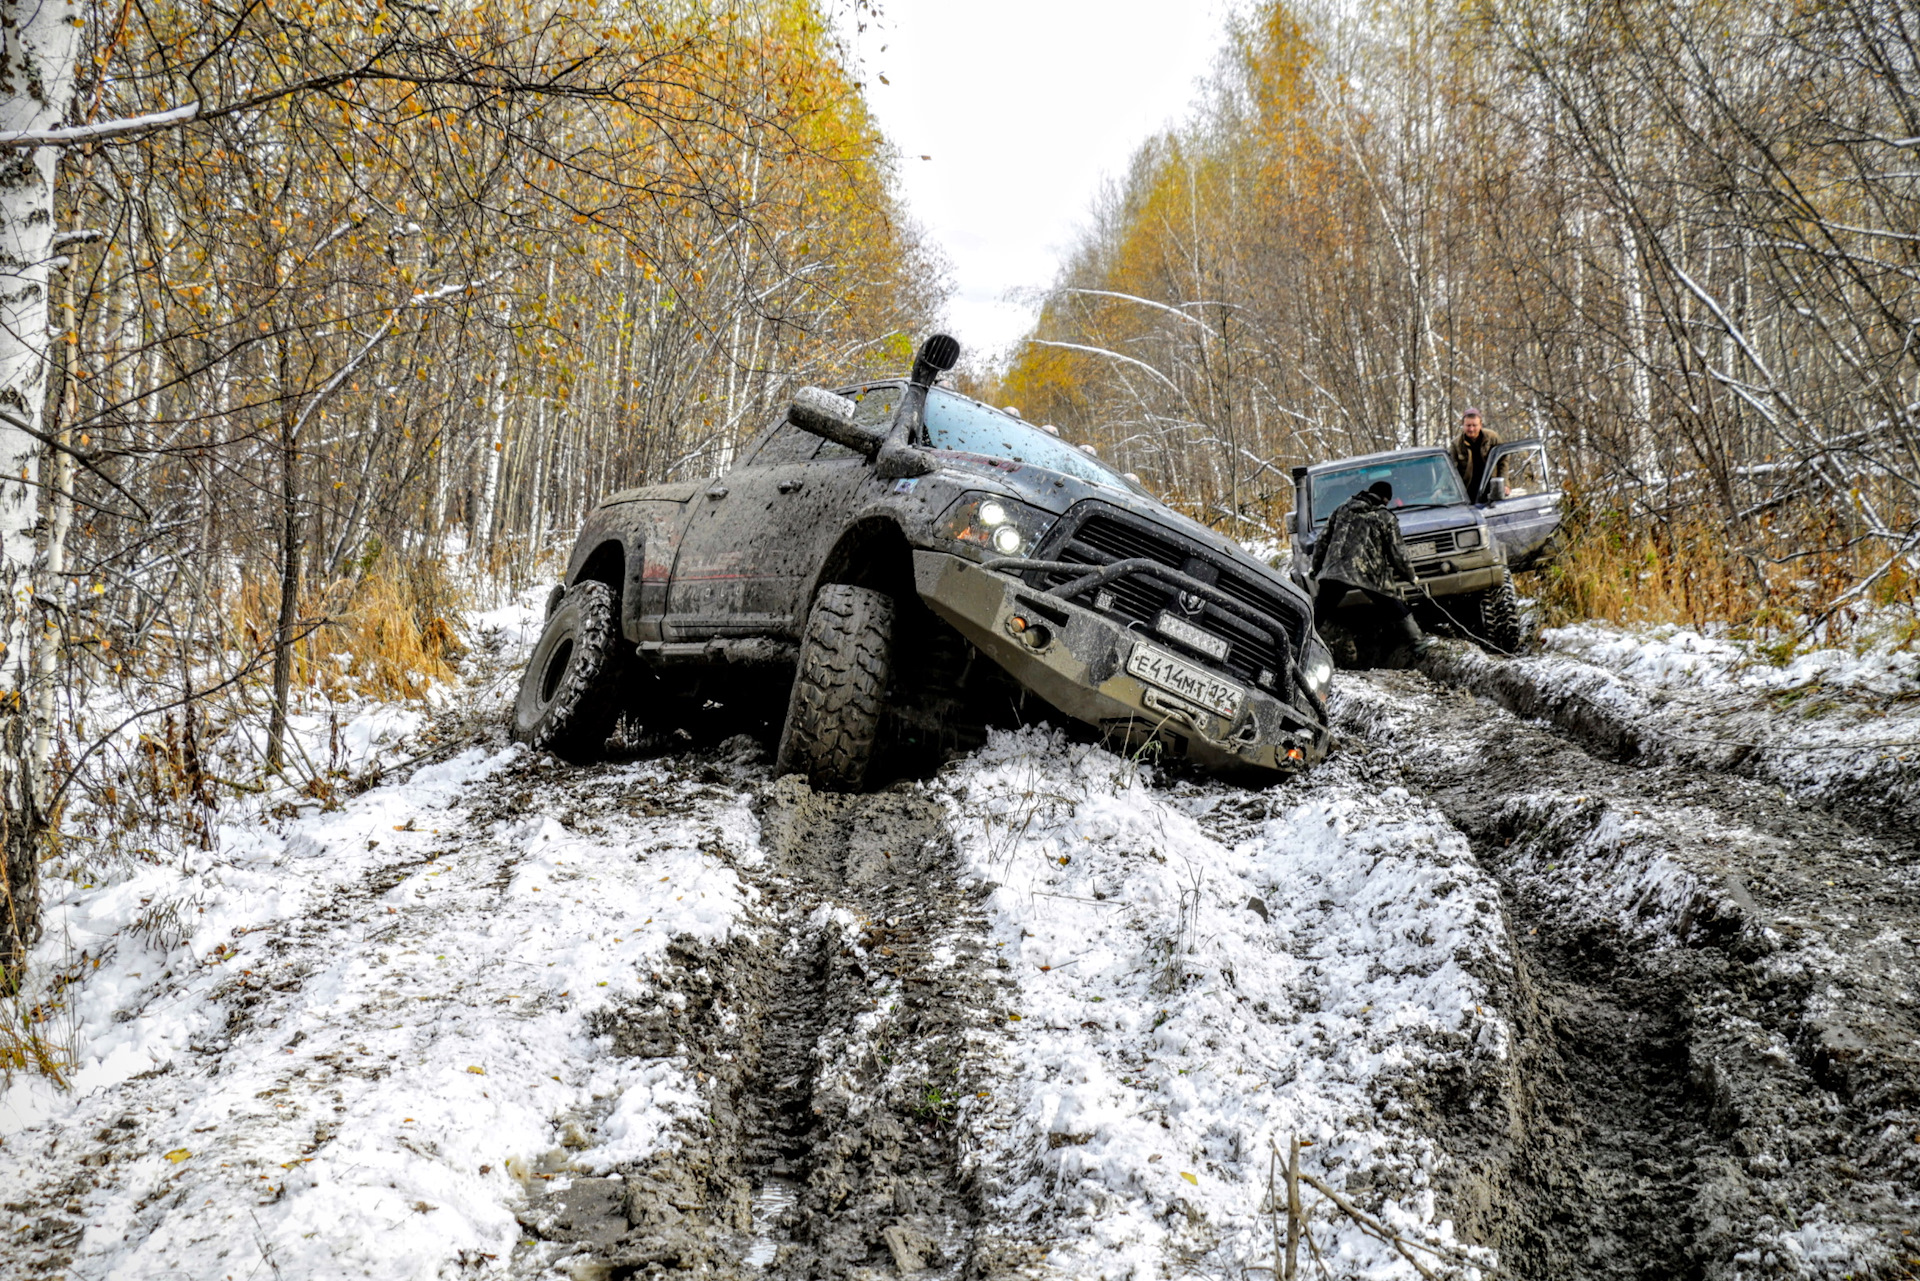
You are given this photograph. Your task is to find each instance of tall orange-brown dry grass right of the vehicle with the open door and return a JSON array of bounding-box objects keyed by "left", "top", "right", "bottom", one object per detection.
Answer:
[{"left": 1523, "top": 497, "right": 1920, "bottom": 661}]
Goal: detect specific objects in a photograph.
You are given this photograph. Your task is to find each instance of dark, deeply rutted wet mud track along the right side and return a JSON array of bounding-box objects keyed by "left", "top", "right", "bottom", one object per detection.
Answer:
[{"left": 1338, "top": 666, "right": 1920, "bottom": 1279}]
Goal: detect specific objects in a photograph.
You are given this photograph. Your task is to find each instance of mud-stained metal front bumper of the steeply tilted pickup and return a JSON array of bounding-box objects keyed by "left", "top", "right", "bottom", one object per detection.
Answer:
[{"left": 914, "top": 551, "right": 1332, "bottom": 774}]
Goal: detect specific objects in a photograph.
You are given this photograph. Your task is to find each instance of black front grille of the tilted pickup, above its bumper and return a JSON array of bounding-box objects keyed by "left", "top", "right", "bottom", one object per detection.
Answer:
[{"left": 1027, "top": 501, "right": 1306, "bottom": 693}]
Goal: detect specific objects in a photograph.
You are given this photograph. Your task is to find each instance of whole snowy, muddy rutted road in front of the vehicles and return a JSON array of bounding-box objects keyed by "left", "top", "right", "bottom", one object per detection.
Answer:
[{"left": 0, "top": 637, "right": 1920, "bottom": 1279}]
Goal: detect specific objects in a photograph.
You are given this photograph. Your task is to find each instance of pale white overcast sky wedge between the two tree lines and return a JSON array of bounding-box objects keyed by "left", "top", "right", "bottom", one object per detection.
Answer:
[{"left": 856, "top": 0, "right": 1227, "bottom": 370}]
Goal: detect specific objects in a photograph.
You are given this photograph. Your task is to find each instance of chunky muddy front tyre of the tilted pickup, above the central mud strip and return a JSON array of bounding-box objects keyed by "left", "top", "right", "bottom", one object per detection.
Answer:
[{"left": 776, "top": 582, "right": 893, "bottom": 791}]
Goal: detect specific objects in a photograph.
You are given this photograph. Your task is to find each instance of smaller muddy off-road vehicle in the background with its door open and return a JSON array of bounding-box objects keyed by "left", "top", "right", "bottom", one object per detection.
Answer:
[{"left": 1286, "top": 438, "right": 1561, "bottom": 666}]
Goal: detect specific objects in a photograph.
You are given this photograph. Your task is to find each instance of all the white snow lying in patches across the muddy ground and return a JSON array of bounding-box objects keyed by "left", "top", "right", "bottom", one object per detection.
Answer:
[{"left": 0, "top": 592, "right": 1920, "bottom": 1281}]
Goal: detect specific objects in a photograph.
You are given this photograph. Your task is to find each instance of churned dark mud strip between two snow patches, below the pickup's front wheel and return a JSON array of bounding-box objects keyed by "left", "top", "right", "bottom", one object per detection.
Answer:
[{"left": 516, "top": 778, "right": 1006, "bottom": 1279}]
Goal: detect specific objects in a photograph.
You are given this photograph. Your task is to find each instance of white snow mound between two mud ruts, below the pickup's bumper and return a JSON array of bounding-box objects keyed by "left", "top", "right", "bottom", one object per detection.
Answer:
[{"left": 939, "top": 728, "right": 1513, "bottom": 1277}]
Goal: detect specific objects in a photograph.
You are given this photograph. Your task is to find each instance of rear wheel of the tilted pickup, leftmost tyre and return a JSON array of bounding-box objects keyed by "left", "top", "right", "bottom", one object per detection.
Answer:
[{"left": 513, "top": 580, "right": 620, "bottom": 761}]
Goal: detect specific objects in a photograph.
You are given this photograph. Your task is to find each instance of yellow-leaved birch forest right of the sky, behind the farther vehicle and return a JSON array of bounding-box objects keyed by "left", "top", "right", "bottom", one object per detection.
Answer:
[{"left": 1000, "top": 0, "right": 1920, "bottom": 640}]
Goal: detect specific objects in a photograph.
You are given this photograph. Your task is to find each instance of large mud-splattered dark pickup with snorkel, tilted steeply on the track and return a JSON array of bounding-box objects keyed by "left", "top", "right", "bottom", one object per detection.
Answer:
[{"left": 513, "top": 334, "right": 1332, "bottom": 791}]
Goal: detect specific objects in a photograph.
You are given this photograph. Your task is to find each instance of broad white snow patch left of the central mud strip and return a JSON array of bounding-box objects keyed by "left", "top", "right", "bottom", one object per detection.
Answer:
[{"left": 0, "top": 587, "right": 760, "bottom": 1277}]
